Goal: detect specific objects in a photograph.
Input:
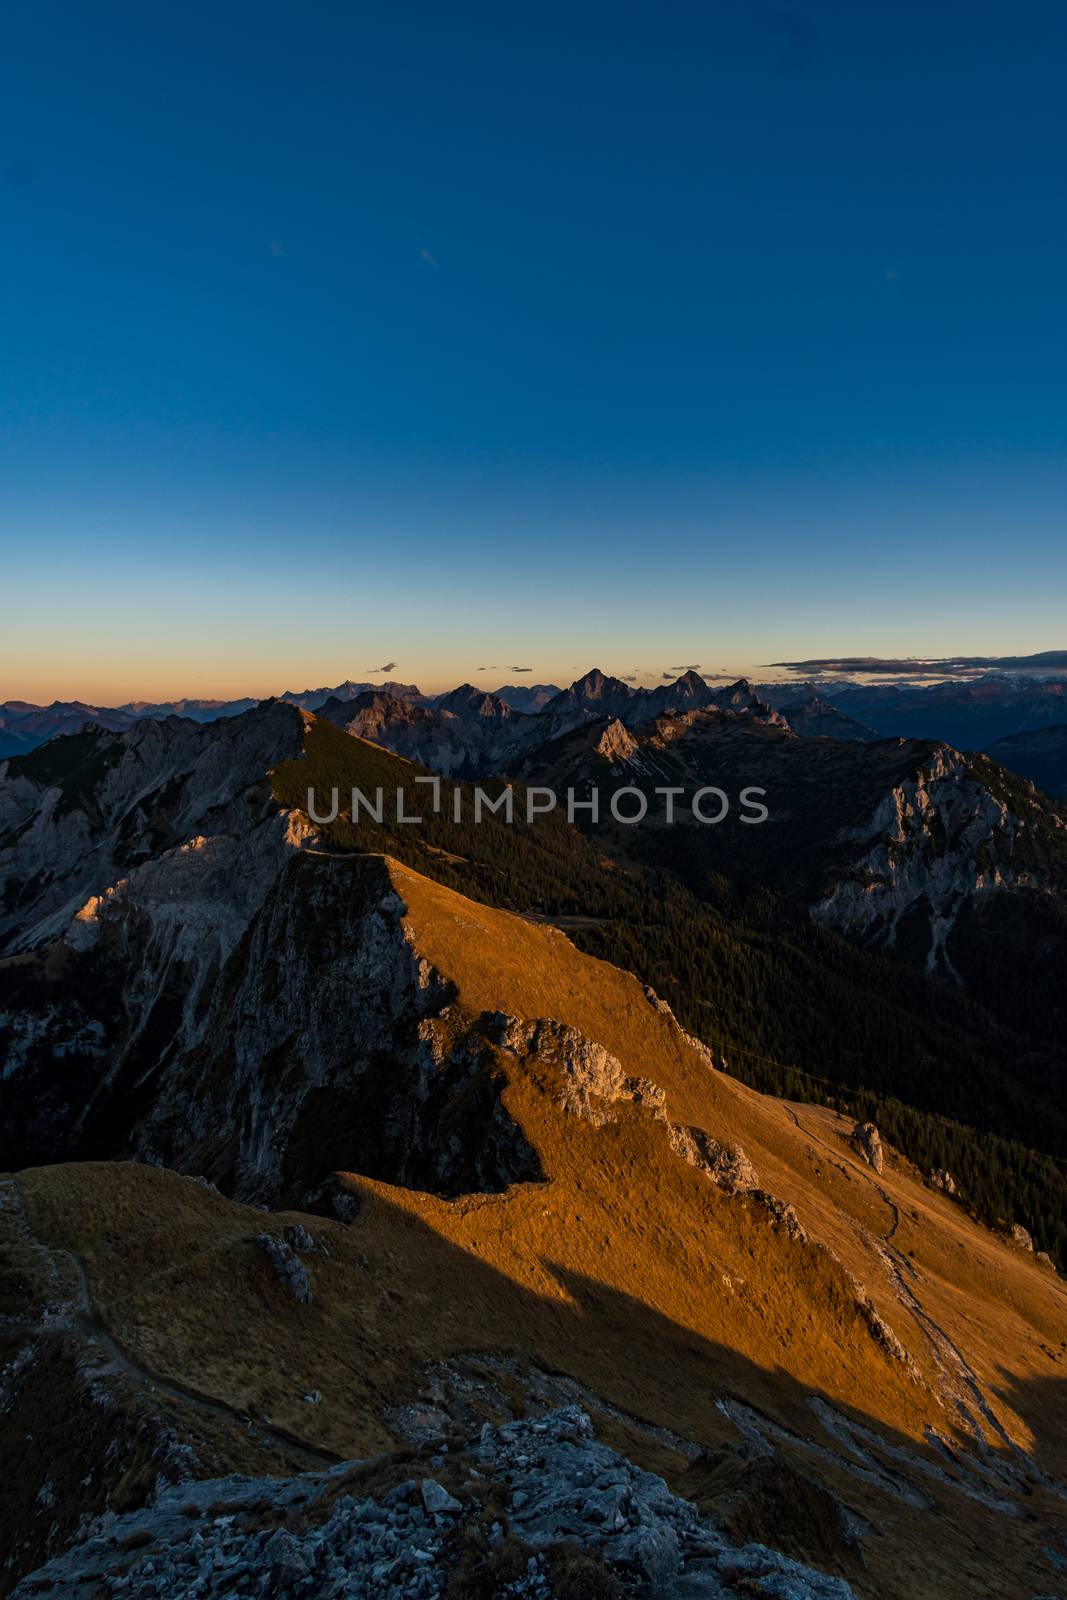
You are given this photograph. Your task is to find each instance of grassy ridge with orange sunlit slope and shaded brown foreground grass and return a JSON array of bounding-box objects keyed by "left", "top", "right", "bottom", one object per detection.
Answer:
[{"left": 0, "top": 848, "right": 1067, "bottom": 1600}]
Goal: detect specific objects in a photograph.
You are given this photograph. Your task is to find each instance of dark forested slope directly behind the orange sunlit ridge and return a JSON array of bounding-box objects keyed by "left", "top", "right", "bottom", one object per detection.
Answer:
[{"left": 272, "top": 718, "right": 1067, "bottom": 1264}]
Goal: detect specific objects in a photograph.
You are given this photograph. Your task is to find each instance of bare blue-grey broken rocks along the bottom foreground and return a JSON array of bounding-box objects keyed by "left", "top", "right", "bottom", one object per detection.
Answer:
[{"left": 14, "top": 1405, "right": 853, "bottom": 1600}]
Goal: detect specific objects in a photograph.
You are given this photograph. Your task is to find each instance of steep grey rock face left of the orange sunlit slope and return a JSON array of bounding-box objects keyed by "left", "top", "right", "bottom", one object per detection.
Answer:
[{"left": 0, "top": 701, "right": 550, "bottom": 1203}]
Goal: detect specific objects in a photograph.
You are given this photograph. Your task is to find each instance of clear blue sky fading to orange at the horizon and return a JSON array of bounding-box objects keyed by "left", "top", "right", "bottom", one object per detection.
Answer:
[{"left": 0, "top": 0, "right": 1067, "bottom": 704}]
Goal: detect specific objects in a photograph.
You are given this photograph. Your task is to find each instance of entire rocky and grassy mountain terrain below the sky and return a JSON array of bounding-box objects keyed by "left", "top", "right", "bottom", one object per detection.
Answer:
[{"left": 0, "top": 672, "right": 1067, "bottom": 1600}]
